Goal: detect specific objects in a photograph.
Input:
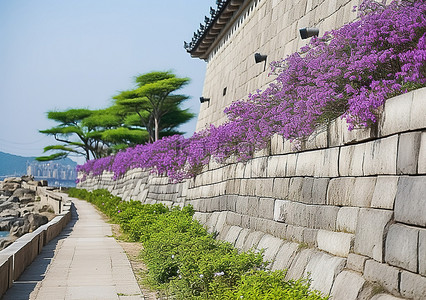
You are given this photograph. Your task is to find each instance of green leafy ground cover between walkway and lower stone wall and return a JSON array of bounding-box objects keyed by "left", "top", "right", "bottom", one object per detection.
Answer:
[{"left": 69, "top": 189, "right": 328, "bottom": 300}]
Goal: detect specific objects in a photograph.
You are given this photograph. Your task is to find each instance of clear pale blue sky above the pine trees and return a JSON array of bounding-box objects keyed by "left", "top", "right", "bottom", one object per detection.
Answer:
[{"left": 0, "top": 0, "right": 216, "bottom": 163}]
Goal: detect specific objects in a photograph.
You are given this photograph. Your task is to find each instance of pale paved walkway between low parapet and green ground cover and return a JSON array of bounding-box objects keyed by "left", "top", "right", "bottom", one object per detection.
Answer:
[{"left": 2, "top": 198, "right": 144, "bottom": 300}]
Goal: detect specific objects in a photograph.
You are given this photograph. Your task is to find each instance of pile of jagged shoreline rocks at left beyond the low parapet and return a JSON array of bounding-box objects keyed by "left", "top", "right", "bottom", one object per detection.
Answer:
[{"left": 0, "top": 176, "right": 55, "bottom": 250}]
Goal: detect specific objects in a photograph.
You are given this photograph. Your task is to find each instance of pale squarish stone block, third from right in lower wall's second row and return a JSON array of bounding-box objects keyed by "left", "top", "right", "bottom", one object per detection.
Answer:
[{"left": 363, "top": 135, "right": 398, "bottom": 176}]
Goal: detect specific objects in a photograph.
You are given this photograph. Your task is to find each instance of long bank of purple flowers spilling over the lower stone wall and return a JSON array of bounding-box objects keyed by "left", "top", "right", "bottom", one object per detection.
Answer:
[{"left": 78, "top": 0, "right": 426, "bottom": 181}]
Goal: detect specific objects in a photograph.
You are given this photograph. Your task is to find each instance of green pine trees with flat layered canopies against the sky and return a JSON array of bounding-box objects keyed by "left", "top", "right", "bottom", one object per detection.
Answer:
[{"left": 36, "top": 71, "right": 194, "bottom": 161}]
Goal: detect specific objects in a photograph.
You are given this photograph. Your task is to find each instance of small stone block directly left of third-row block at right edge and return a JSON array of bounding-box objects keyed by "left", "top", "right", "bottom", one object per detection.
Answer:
[{"left": 371, "top": 176, "right": 399, "bottom": 209}]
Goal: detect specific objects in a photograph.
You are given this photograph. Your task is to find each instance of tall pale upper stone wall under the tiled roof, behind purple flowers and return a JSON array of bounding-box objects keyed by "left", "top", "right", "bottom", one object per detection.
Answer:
[{"left": 197, "top": 0, "right": 360, "bottom": 131}]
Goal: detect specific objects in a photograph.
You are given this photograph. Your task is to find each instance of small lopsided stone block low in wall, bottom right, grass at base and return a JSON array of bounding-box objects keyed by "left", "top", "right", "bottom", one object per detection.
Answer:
[{"left": 364, "top": 259, "right": 399, "bottom": 294}]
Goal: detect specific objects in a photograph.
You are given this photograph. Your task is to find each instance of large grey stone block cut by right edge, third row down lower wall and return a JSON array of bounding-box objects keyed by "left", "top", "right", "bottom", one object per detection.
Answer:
[{"left": 395, "top": 176, "right": 426, "bottom": 227}]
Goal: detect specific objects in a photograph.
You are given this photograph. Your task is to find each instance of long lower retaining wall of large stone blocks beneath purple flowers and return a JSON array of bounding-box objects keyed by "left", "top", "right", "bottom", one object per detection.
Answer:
[{"left": 79, "top": 88, "right": 426, "bottom": 300}]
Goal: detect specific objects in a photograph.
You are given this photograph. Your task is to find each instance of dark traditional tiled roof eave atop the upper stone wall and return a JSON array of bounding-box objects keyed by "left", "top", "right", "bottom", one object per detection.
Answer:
[{"left": 183, "top": 0, "right": 245, "bottom": 59}]
